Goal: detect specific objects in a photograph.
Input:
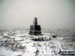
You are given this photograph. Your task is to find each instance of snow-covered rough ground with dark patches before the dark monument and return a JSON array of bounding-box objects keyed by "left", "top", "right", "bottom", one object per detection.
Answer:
[{"left": 0, "top": 32, "right": 75, "bottom": 56}]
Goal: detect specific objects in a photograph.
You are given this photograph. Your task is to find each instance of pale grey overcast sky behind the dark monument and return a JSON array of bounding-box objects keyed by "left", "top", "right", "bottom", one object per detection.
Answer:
[{"left": 0, "top": 0, "right": 75, "bottom": 29}]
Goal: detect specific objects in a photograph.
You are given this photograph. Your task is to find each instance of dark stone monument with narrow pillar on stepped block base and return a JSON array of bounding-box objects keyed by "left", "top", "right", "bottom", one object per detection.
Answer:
[{"left": 29, "top": 17, "right": 41, "bottom": 36}]
